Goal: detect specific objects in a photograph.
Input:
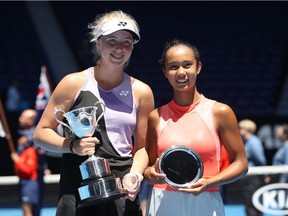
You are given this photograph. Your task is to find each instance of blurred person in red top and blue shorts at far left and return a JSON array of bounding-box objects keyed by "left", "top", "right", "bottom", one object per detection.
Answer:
[{"left": 11, "top": 109, "right": 39, "bottom": 216}]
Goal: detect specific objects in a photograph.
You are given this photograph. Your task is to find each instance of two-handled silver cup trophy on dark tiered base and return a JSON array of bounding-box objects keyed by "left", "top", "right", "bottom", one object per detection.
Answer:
[{"left": 54, "top": 101, "right": 126, "bottom": 208}]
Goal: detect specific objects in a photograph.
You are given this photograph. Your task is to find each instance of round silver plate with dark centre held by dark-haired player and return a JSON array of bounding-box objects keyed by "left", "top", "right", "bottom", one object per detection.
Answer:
[{"left": 158, "top": 145, "right": 204, "bottom": 188}]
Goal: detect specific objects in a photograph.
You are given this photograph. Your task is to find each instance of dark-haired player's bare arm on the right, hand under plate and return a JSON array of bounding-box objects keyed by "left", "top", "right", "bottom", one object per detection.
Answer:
[{"left": 180, "top": 103, "right": 248, "bottom": 194}]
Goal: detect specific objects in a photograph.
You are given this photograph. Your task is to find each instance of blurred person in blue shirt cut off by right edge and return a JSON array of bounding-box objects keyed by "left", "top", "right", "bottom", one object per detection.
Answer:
[{"left": 273, "top": 124, "right": 288, "bottom": 182}]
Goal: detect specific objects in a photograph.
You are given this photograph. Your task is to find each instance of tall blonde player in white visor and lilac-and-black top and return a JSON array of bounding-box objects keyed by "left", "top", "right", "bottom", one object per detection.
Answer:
[{"left": 34, "top": 11, "right": 154, "bottom": 216}]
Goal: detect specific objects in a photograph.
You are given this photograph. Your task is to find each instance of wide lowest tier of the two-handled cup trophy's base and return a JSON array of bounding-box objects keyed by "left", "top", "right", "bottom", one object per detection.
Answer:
[{"left": 77, "top": 176, "right": 126, "bottom": 208}]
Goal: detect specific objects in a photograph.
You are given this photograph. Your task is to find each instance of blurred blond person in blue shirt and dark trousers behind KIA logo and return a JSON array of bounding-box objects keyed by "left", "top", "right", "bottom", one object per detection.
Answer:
[{"left": 239, "top": 119, "right": 267, "bottom": 216}]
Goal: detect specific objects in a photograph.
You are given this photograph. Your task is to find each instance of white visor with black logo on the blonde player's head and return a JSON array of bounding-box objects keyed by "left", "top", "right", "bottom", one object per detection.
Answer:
[{"left": 96, "top": 20, "right": 140, "bottom": 44}]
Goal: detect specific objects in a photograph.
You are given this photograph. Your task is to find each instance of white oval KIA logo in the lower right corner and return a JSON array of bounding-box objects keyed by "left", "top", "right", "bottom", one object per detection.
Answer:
[{"left": 252, "top": 183, "right": 288, "bottom": 215}]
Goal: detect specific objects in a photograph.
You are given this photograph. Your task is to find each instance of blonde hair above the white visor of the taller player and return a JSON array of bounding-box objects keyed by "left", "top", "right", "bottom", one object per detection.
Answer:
[{"left": 88, "top": 10, "right": 139, "bottom": 43}]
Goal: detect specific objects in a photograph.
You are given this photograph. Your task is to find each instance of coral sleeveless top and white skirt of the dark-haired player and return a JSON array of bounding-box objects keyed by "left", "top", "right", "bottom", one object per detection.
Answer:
[{"left": 147, "top": 95, "right": 225, "bottom": 216}]
